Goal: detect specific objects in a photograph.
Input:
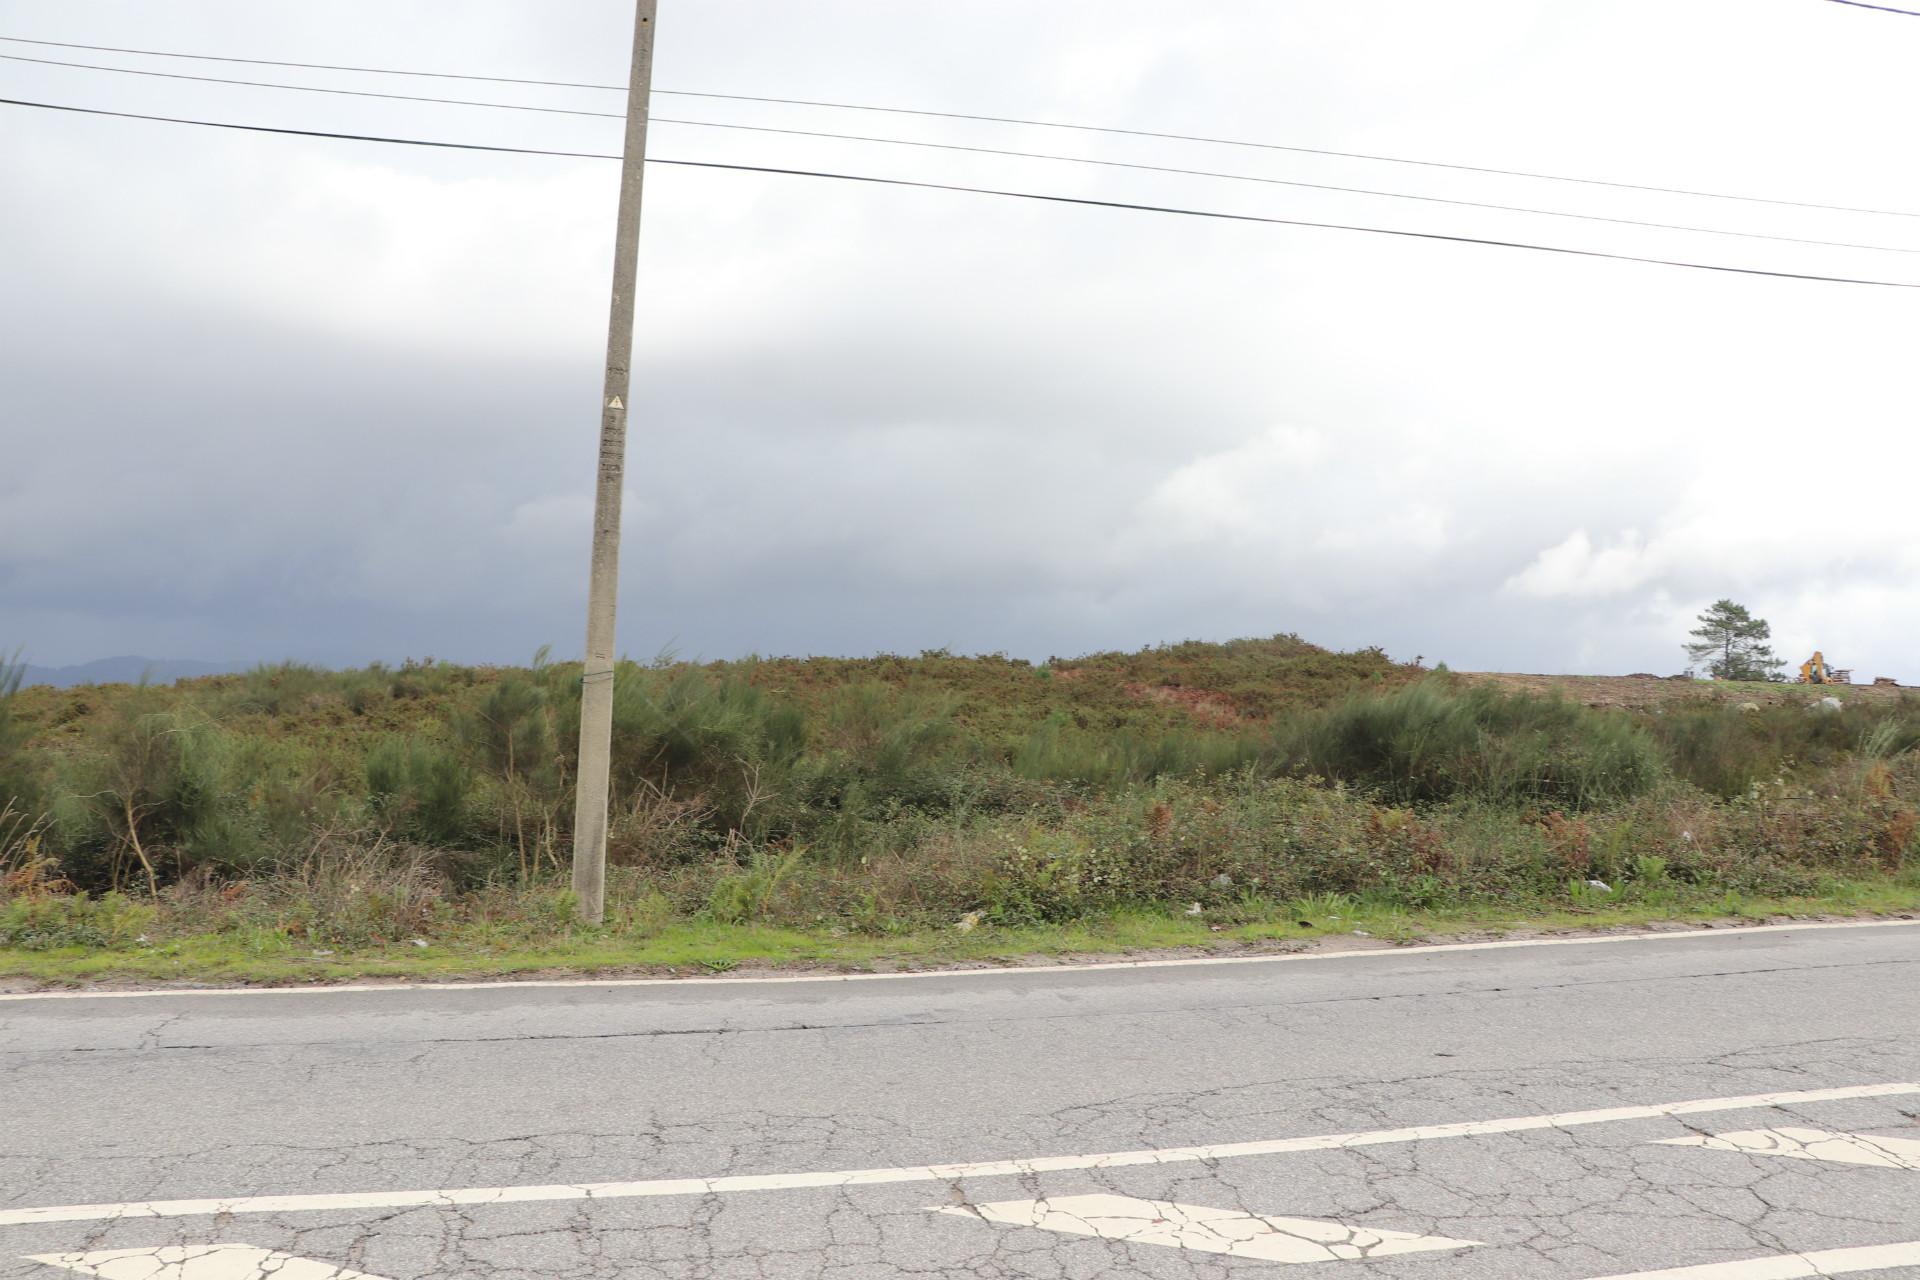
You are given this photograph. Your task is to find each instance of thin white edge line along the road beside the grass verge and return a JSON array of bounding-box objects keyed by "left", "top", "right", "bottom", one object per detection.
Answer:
[{"left": 0, "top": 919, "right": 1920, "bottom": 1002}]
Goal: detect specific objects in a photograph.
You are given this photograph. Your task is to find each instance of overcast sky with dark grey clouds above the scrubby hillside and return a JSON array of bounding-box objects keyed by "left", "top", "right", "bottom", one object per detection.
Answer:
[{"left": 0, "top": 0, "right": 1920, "bottom": 681}]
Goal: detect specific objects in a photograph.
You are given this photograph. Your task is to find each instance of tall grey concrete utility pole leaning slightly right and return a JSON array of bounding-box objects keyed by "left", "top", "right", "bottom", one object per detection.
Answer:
[{"left": 574, "top": 0, "right": 659, "bottom": 925}]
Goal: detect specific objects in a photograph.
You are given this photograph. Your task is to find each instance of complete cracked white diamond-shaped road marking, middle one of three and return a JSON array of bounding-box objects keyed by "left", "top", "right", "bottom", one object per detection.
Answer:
[{"left": 933, "top": 1196, "right": 1480, "bottom": 1263}]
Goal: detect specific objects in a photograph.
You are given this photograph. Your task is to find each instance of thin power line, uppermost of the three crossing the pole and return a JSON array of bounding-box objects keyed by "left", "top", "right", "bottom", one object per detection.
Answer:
[{"left": 0, "top": 30, "right": 1920, "bottom": 217}]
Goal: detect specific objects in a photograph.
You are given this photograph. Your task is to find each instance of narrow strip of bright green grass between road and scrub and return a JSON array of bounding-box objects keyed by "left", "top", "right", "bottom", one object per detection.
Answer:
[{"left": 0, "top": 877, "right": 1920, "bottom": 988}]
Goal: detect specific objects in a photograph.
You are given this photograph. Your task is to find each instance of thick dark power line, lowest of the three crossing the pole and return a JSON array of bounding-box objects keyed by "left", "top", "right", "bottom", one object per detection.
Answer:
[{"left": 0, "top": 98, "right": 1920, "bottom": 290}]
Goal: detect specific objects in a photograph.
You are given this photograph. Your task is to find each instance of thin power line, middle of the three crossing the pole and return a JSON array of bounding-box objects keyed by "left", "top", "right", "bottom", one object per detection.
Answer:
[{"left": 0, "top": 54, "right": 1920, "bottom": 253}]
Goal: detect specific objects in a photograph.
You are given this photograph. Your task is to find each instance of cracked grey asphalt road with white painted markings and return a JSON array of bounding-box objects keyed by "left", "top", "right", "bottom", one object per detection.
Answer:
[{"left": 0, "top": 923, "right": 1920, "bottom": 1280}]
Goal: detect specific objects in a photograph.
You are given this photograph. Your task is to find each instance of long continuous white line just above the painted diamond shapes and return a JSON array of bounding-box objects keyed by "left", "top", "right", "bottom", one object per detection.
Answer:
[{"left": 0, "top": 1082, "right": 1920, "bottom": 1226}]
